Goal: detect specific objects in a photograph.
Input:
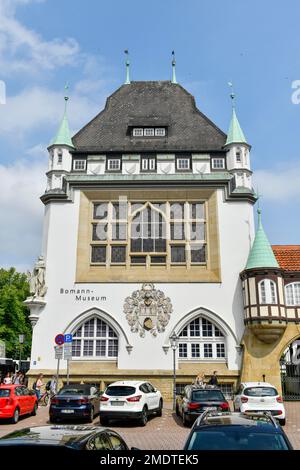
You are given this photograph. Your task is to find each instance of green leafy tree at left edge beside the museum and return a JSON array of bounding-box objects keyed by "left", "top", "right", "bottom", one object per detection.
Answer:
[{"left": 0, "top": 268, "right": 31, "bottom": 359}]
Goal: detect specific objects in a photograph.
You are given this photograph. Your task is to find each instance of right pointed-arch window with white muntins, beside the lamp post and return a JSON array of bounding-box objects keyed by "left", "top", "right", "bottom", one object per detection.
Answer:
[{"left": 178, "top": 317, "right": 226, "bottom": 362}]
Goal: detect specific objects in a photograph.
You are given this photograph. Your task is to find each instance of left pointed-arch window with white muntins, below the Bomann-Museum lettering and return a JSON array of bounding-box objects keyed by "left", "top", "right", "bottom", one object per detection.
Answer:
[{"left": 72, "top": 318, "right": 118, "bottom": 359}]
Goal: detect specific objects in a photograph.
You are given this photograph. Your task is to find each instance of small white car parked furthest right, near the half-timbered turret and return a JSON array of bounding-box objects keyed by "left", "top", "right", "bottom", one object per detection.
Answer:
[{"left": 233, "top": 382, "right": 285, "bottom": 426}]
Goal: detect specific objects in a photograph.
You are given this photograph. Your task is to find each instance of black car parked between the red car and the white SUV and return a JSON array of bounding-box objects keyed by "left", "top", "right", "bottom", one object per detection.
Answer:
[{"left": 49, "top": 384, "right": 101, "bottom": 423}]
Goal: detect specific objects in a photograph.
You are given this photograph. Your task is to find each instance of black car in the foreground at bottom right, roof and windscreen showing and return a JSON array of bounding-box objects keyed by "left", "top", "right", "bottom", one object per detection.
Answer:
[{"left": 184, "top": 411, "right": 293, "bottom": 451}]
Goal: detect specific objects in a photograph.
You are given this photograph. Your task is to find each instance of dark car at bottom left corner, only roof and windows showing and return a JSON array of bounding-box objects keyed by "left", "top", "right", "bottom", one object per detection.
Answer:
[{"left": 0, "top": 425, "right": 135, "bottom": 452}]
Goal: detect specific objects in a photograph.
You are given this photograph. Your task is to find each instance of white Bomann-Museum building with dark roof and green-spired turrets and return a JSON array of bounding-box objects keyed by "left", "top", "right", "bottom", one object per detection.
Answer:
[{"left": 26, "top": 57, "right": 300, "bottom": 397}]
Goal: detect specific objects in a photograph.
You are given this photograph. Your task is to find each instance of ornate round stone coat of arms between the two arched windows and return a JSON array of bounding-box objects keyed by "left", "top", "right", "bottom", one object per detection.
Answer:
[{"left": 123, "top": 283, "right": 173, "bottom": 338}]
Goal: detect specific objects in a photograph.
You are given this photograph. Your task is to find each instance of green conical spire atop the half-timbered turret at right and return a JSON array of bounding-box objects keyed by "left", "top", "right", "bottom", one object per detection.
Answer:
[{"left": 246, "top": 209, "right": 279, "bottom": 269}]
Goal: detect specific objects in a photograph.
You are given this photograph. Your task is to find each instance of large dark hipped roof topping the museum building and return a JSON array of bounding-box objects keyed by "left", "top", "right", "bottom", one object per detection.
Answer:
[{"left": 72, "top": 81, "right": 226, "bottom": 152}]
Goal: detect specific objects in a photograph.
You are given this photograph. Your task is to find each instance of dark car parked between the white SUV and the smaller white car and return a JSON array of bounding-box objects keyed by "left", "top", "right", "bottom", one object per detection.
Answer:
[{"left": 176, "top": 385, "right": 230, "bottom": 426}]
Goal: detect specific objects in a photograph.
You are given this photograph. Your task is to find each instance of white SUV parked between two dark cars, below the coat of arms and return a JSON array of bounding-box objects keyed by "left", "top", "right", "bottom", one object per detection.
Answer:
[{"left": 100, "top": 380, "right": 163, "bottom": 426}]
